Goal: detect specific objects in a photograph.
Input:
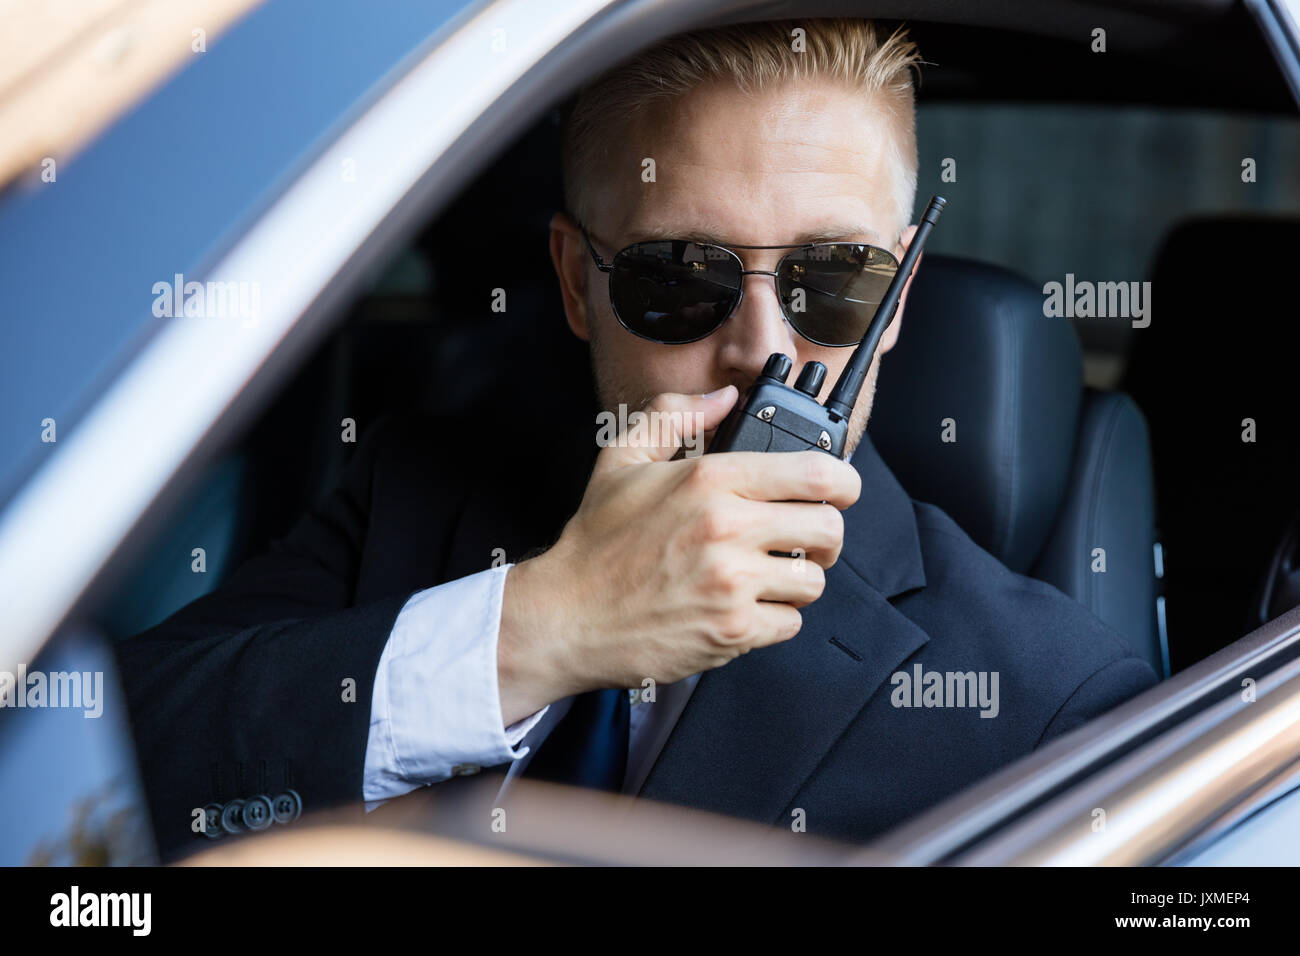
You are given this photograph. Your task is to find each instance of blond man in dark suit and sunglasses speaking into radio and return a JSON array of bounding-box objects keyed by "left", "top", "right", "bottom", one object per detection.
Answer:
[{"left": 121, "top": 21, "right": 1154, "bottom": 852}]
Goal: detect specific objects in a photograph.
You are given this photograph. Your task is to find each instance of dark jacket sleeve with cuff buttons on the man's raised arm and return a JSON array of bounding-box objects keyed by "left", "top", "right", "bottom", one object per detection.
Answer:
[{"left": 116, "top": 423, "right": 410, "bottom": 860}]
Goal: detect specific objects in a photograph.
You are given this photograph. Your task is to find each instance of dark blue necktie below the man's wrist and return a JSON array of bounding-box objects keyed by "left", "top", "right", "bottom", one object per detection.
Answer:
[{"left": 524, "top": 688, "right": 632, "bottom": 793}]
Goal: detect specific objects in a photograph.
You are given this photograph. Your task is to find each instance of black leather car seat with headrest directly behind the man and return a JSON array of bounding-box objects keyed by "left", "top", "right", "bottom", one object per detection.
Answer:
[{"left": 867, "top": 254, "right": 1169, "bottom": 675}]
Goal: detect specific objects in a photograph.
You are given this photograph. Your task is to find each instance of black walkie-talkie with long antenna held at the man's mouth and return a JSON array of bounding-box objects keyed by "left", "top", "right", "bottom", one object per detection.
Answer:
[{"left": 706, "top": 196, "right": 948, "bottom": 458}]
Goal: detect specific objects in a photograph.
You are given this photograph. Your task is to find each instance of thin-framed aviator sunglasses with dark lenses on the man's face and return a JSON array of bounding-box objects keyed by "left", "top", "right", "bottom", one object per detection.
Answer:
[{"left": 582, "top": 228, "right": 898, "bottom": 347}]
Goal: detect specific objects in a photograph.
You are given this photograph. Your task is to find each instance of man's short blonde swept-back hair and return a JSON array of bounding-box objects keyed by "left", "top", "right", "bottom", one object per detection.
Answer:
[{"left": 563, "top": 18, "right": 922, "bottom": 230}]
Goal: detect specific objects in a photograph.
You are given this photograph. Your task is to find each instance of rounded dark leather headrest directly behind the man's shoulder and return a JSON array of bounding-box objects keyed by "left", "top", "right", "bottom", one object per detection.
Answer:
[{"left": 867, "top": 254, "right": 1083, "bottom": 574}]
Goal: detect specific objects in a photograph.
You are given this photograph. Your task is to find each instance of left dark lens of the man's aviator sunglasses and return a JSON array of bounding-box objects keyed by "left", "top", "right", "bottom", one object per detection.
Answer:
[{"left": 610, "top": 239, "right": 741, "bottom": 345}]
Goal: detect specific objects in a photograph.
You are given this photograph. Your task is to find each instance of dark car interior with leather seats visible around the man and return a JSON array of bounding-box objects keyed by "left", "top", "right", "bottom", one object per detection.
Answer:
[{"left": 101, "top": 12, "right": 1300, "bottom": 712}]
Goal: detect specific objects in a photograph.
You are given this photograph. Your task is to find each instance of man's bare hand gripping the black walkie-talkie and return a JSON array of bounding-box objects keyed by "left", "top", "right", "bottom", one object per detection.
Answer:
[{"left": 498, "top": 388, "right": 862, "bottom": 724}]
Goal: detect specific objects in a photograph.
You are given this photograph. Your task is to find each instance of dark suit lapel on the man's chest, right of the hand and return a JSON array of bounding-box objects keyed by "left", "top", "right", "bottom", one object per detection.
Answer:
[{"left": 638, "top": 437, "right": 930, "bottom": 822}]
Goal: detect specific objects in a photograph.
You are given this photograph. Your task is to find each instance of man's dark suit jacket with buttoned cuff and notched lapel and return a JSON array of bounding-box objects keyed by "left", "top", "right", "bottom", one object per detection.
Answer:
[{"left": 118, "top": 415, "right": 1156, "bottom": 857}]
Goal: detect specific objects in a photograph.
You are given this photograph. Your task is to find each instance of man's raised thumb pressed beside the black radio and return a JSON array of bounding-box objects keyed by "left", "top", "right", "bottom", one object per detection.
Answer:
[{"left": 595, "top": 385, "right": 740, "bottom": 471}]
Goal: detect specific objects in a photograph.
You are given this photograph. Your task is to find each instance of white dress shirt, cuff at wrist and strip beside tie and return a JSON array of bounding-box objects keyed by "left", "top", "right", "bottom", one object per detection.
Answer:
[{"left": 363, "top": 564, "right": 699, "bottom": 810}]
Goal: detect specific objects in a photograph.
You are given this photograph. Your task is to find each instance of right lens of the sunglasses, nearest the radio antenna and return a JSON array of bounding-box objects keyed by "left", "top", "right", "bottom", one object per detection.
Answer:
[{"left": 776, "top": 242, "right": 898, "bottom": 346}]
